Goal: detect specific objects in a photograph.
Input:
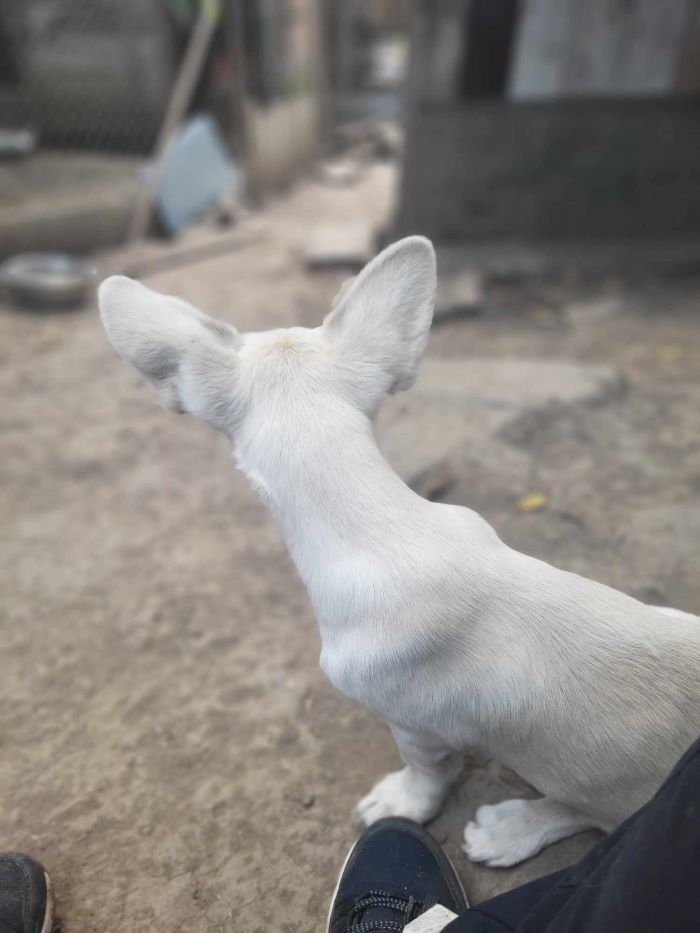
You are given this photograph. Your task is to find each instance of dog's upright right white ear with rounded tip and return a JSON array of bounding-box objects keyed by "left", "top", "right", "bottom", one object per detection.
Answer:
[{"left": 323, "top": 236, "right": 437, "bottom": 411}]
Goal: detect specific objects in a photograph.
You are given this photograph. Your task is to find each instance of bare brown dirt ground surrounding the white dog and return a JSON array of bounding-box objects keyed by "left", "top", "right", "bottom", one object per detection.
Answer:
[{"left": 0, "top": 166, "right": 700, "bottom": 933}]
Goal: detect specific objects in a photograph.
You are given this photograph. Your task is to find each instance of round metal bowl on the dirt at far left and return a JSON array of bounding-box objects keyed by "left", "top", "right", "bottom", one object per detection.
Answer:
[{"left": 0, "top": 253, "right": 97, "bottom": 310}]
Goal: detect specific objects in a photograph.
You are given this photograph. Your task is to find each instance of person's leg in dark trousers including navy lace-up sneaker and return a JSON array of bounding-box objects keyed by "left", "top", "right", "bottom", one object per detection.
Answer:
[{"left": 328, "top": 740, "right": 700, "bottom": 933}]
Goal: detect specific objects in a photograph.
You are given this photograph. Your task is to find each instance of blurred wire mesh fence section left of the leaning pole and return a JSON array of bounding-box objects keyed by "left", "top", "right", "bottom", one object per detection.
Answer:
[{"left": 0, "top": 0, "right": 188, "bottom": 152}]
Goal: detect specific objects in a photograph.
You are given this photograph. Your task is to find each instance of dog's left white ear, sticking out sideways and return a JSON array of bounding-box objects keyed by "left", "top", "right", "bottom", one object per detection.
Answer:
[{"left": 98, "top": 275, "right": 241, "bottom": 427}]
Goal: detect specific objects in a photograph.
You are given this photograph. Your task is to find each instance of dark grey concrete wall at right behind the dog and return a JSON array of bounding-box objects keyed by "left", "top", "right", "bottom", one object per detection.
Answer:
[{"left": 396, "top": 99, "right": 700, "bottom": 240}]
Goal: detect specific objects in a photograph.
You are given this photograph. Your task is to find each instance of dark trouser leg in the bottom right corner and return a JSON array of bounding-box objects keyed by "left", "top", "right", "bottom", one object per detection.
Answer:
[{"left": 444, "top": 739, "right": 700, "bottom": 933}]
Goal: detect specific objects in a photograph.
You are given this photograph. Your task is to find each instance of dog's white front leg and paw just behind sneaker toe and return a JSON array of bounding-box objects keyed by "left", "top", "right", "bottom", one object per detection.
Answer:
[{"left": 357, "top": 726, "right": 463, "bottom": 826}]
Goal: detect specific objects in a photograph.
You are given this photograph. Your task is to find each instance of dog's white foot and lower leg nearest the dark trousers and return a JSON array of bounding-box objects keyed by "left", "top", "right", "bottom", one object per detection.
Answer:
[{"left": 464, "top": 797, "right": 599, "bottom": 868}]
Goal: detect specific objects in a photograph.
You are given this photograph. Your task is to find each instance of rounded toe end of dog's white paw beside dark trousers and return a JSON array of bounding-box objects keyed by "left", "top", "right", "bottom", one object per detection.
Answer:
[{"left": 463, "top": 800, "right": 542, "bottom": 868}]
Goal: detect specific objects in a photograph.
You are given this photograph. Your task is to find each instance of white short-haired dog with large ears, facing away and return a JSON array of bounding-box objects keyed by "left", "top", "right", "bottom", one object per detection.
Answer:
[{"left": 100, "top": 237, "right": 700, "bottom": 865}]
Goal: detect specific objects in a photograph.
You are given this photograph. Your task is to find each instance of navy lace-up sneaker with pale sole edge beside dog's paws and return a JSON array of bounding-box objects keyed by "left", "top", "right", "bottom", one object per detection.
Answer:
[{"left": 328, "top": 817, "right": 468, "bottom": 933}]
